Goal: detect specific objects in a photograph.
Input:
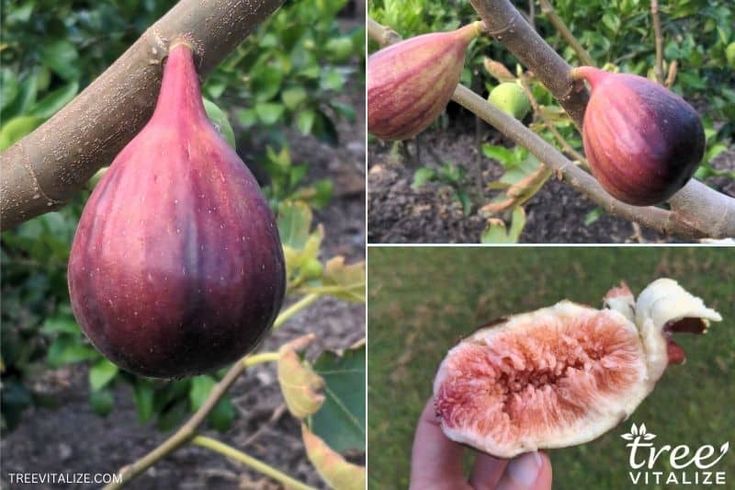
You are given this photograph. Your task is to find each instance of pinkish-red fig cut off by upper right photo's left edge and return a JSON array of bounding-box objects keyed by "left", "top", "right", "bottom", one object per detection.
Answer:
[{"left": 367, "top": 21, "right": 484, "bottom": 140}]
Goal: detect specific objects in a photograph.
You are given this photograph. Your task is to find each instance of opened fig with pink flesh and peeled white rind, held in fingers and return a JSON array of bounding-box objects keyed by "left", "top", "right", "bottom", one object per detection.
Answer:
[{"left": 434, "top": 279, "right": 722, "bottom": 458}]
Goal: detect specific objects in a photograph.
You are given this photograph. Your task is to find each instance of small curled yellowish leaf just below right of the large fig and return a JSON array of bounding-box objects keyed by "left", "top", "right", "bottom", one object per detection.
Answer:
[{"left": 278, "top": 334, "right": 324, "bottom": 419}]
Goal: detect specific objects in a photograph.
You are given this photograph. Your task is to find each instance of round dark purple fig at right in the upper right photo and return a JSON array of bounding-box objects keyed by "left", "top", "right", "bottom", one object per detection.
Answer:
[{"left": 572, "top": 66, "right": 705, "bottom": 206}]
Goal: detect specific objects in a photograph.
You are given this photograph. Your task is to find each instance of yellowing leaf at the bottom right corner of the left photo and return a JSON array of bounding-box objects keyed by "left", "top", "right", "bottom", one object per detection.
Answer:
[{"left": 301, "top": 424, "right": 366, "bottom": 490}]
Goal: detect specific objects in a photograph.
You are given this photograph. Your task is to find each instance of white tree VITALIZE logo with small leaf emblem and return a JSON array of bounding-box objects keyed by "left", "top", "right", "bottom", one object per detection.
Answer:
[{"left": 620, "top": 424, "right": 730, "bottom": 486}]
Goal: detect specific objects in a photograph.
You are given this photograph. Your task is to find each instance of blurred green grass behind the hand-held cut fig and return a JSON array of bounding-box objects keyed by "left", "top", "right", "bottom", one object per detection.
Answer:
[{"left": 368, "top": 247, "right": 735, "bottom": 490}]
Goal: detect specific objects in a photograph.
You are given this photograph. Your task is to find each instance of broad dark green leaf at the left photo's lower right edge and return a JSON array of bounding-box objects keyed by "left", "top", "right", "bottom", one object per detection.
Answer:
[{"left": 310, "top": 344, "right": 365, "bottom": 452}]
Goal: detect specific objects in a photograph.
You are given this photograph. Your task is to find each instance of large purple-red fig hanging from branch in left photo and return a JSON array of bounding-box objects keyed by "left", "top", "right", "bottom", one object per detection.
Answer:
[{"left": 69, "top": 42, "right": 286, "bottom": 378}]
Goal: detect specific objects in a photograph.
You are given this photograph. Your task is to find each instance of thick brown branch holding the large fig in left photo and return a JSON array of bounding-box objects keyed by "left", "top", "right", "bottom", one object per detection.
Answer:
[{"left": 0, "top": 0, "right": 282, "bottom": 229}]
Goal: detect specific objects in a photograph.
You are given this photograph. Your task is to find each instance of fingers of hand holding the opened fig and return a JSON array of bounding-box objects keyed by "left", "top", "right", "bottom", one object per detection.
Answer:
[{"left": 410, "top": 399, "right": 551, "bottom": 490}]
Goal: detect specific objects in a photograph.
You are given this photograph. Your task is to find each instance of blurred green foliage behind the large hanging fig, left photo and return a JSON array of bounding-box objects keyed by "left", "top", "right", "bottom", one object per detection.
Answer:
[{"left": 0, "top": 0, "right": 365, "bottom": 430}]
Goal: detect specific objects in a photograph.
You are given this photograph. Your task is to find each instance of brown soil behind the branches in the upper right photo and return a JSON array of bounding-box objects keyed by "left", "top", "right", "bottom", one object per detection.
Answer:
[{"left": 368, "top": 105, "right": 735, "bottom": 243}]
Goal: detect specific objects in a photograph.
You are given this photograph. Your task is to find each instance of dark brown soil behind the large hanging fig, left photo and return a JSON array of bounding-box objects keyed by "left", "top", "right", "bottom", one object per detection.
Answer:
[{"left": 0, "top": 44, "right": 365, "bottom": 490}]
